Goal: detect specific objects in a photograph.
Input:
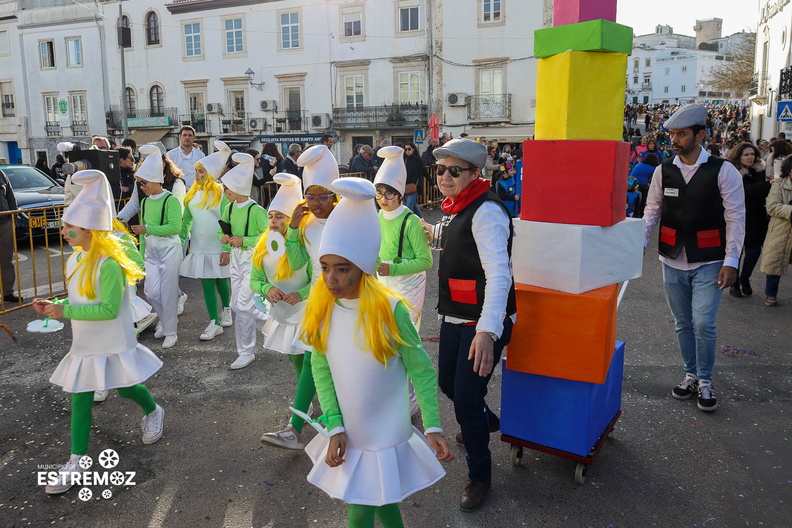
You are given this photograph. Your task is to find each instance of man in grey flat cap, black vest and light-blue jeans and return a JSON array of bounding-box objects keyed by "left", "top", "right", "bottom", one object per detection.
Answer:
[{"left": 644, "top": 104, "right": 745, "bottom": 411}]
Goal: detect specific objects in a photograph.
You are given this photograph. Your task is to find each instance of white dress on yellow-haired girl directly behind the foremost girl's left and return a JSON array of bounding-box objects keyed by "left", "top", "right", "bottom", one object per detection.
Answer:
[{"left": 261, "top": 252, "right": 311, "bottom": 354}]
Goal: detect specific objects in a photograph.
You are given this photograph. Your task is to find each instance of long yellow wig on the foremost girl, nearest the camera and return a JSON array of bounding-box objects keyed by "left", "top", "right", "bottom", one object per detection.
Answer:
[{"left": 300, "top": 273, "right": 410, "bottom": 365}]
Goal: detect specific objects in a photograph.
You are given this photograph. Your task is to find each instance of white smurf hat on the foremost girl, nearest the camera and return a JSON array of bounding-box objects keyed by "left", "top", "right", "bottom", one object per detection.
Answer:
[{"left": 319, "top": 177, "right": 382, "bottom": 275}]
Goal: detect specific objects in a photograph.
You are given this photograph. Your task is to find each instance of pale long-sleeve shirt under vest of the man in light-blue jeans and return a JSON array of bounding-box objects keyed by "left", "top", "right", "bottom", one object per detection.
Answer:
[{"left": 644, "top": 149, "right": 745, "bottom": 270}]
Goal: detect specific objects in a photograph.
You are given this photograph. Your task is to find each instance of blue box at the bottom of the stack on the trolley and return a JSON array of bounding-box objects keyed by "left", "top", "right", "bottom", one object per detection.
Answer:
[{"left": 501, "top": 341, "right": 624, "bottom": 456}]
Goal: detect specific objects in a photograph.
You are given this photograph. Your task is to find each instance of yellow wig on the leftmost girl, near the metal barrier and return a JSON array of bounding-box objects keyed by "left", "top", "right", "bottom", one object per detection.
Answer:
[{"left": 66, "top": 230, "right": 145, "bottom": 299}]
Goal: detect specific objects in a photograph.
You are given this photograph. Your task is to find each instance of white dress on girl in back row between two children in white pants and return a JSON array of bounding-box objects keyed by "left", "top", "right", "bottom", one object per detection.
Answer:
[{"left": 179, "top": 190, "right": 231, "bottom": 279}]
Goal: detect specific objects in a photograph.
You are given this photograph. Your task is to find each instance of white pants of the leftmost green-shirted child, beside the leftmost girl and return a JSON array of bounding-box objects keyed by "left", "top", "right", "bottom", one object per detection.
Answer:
[{"left": 143, "top": 236, "right": 182, "bottom": 336}]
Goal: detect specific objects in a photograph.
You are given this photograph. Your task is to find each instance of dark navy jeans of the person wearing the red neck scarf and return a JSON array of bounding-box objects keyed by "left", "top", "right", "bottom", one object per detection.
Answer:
[{"left": 437, "top": 319, "right": 512, "bottom": 482}]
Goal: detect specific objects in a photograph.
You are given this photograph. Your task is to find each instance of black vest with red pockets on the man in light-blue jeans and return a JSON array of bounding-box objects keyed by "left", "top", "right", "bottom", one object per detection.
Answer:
[{"left": 659, "top": 156, "right": 726, "bottom": 262}]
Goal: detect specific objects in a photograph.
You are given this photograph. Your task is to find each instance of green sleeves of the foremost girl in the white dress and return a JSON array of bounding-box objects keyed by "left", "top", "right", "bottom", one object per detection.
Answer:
[{"left": 311, "top": 301, "right": 440, "bottom": 431}]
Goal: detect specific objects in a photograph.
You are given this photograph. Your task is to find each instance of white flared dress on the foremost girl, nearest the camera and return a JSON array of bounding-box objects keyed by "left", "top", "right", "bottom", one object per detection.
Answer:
[{"left": 305, "top": 299, "right": 445, "bottom": 506}]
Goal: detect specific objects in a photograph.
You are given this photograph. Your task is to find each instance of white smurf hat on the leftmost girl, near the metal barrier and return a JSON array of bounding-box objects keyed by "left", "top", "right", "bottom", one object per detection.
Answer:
[{"left": 61, "top": 169, "right": 115, "bottom": 231}]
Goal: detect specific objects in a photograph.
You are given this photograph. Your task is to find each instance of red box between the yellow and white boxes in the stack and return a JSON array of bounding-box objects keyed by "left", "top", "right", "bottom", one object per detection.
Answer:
[{"left": 520, "top": 140, "right": 630, "bottom": 227}]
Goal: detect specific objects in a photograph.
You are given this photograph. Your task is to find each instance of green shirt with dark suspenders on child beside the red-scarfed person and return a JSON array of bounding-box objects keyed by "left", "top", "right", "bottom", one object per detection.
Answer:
[{"left": 379, "top": 208, "right": 432, "bottom": 277}]
